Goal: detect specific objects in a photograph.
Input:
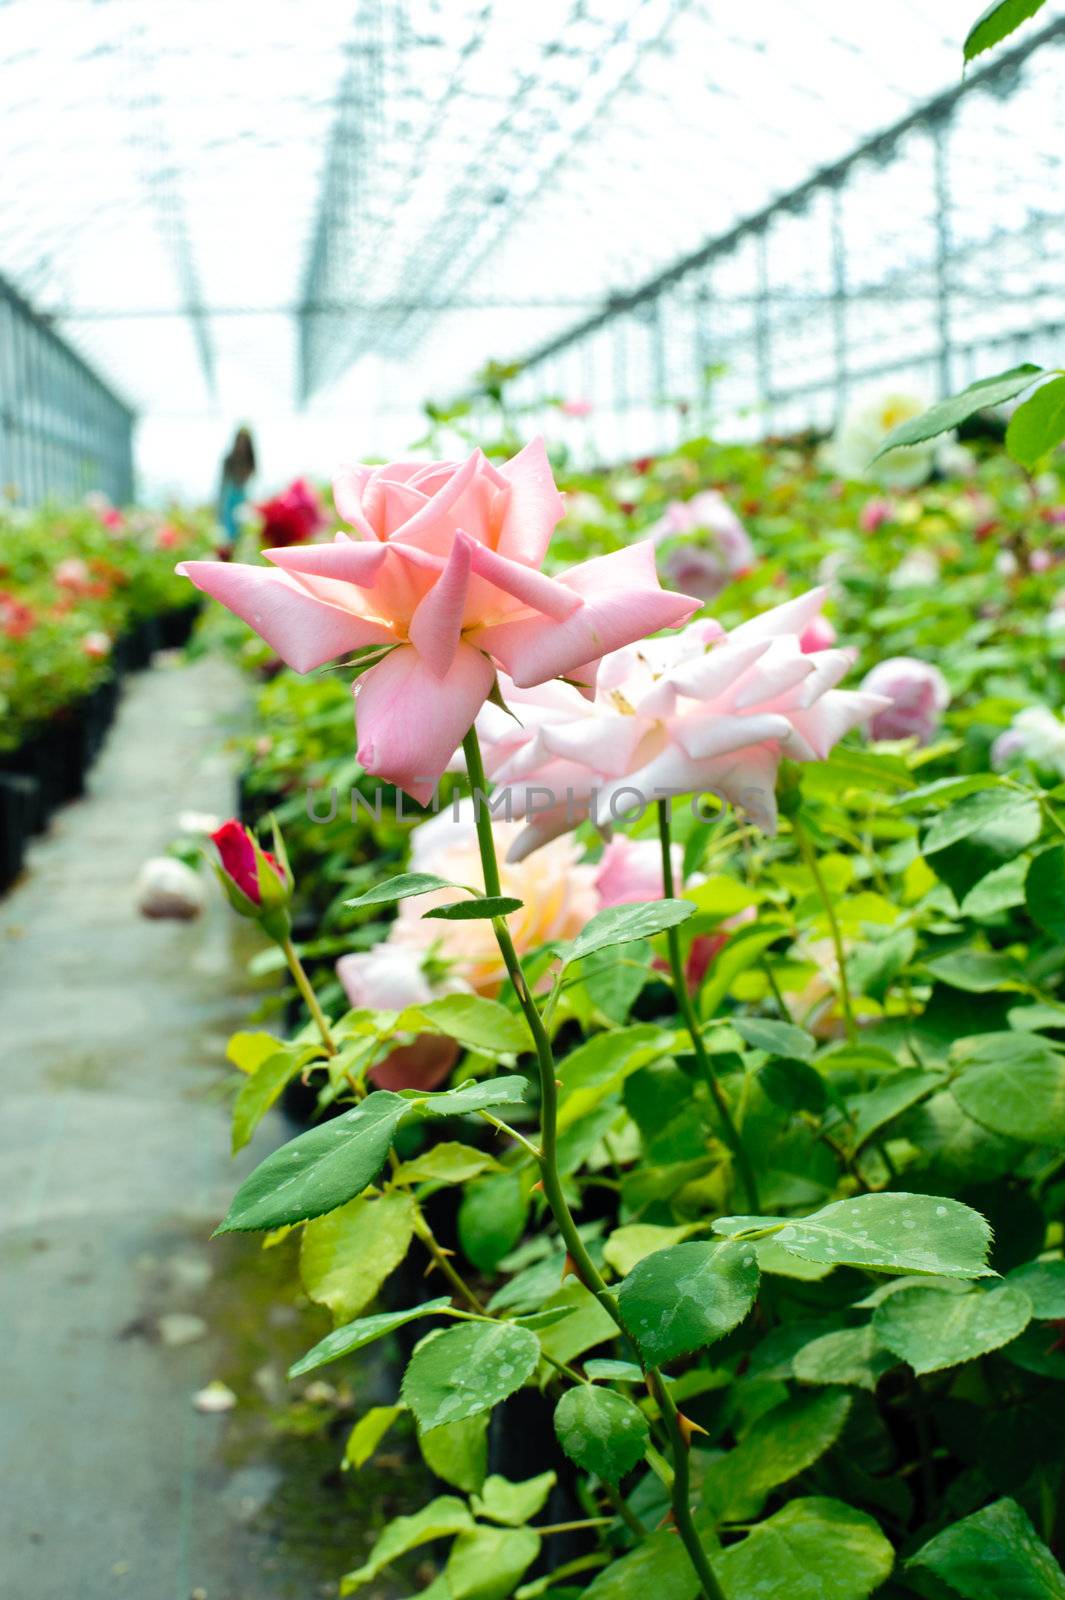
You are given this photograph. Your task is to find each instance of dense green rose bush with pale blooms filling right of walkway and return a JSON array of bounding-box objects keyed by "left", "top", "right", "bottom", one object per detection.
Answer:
[{"left": 192, "top": 422, "right": 1065, "bottom": 1600}]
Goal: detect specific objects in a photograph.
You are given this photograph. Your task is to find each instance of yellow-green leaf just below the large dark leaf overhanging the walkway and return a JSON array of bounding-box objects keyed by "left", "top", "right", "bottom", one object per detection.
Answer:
[{"left": 299, "top": 1194, "right": 416, "bottom": 1322}]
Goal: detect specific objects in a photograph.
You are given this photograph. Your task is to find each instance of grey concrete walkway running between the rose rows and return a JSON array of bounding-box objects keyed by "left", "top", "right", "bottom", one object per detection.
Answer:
[{"left": 0, "top": 661, "right": 422, "bottom": 1600}]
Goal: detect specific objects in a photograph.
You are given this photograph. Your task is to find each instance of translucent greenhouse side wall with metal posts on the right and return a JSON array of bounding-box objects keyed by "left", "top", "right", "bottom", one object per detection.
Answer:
[{"left": 510, "top": 10, "right": 1065, "bottom": 462}]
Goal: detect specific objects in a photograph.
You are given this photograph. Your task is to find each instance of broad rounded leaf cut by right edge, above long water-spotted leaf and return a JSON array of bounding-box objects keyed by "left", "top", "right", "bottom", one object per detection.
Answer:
[{"left": 951, "top": 1034, "right": 1065, "bottom": 1144}]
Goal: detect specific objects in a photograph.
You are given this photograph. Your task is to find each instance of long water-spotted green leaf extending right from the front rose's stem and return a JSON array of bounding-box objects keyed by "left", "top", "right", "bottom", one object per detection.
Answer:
[{"left": 713, "top": 1192, "right": 995, "bottom": 1278}]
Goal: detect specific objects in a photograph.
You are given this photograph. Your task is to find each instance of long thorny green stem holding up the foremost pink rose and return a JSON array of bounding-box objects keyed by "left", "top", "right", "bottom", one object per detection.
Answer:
[{"left": 462, "top": 728, "right": 724, "bottom": 1600}]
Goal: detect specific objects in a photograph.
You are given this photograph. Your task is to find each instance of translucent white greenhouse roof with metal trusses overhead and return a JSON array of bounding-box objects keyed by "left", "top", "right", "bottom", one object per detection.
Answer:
[{"left": 0, "top": 0, "right": 1063, "bottom": 444}]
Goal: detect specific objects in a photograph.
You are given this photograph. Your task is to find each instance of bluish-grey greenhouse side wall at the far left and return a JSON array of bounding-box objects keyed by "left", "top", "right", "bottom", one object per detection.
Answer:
[{"left": 0, "top": 280, "right": 134, "bottom": 506}]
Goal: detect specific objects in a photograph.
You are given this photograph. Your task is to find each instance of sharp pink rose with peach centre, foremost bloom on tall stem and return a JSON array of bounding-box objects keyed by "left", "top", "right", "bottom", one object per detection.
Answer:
[{"left": 178, "top": 440, "right": 697, "bottom": 803}]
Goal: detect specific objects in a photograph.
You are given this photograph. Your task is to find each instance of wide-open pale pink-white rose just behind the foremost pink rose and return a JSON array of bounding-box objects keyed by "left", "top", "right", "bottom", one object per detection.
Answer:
[{"left": 478, "top": 589, "right": 889, "bottom": 859}]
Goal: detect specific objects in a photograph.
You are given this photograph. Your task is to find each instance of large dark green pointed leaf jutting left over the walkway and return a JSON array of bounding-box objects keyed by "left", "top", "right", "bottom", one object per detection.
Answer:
[{"left": 216, "top": 1090, "right": 411, "bottom": 1234}]
